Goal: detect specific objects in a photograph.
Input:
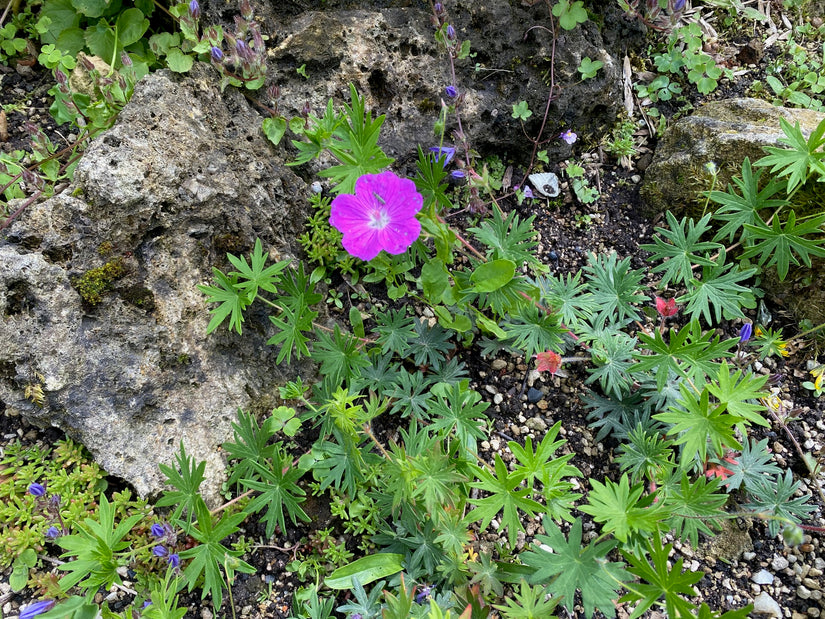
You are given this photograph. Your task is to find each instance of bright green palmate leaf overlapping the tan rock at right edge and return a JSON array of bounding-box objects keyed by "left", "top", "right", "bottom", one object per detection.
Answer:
[{"left": 754, "top": 118, "right": 825, "bottom": 194}]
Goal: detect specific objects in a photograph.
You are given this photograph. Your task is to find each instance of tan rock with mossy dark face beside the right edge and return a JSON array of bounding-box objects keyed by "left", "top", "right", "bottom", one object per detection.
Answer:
[{"left": 641, "top": 99, "right": 825, "bottom": 216}]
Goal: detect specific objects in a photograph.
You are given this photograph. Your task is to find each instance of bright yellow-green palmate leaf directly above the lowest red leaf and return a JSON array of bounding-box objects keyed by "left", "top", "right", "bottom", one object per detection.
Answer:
[{"left": 653, "top": 383, "right": 741, "bottom": 469}]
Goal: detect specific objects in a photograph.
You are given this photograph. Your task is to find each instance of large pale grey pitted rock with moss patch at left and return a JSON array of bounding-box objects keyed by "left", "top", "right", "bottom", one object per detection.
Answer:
[{"left": 0, "top": 65, "right": 307, "bottom": 503}]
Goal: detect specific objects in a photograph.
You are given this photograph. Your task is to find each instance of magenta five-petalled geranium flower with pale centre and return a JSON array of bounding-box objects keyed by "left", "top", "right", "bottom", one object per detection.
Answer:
[{"left": 329, "top": 171, "right": 424, "bottom": 260}]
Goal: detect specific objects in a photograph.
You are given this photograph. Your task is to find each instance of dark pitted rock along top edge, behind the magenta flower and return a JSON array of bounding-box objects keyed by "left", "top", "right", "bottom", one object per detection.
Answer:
[{"left": 212, "top": 0, "right": 627, "bottom": 165}]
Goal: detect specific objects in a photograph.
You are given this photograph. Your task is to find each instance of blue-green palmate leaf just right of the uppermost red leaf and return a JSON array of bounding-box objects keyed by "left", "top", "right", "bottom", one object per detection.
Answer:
[{"left": 677, "top": 250, "right": 757, "bottom": 325}]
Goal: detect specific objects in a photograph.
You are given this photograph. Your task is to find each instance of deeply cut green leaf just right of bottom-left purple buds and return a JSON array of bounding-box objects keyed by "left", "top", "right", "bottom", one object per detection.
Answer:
[{"left": 177, "top": 500, "right": 255, "bottom": 610}]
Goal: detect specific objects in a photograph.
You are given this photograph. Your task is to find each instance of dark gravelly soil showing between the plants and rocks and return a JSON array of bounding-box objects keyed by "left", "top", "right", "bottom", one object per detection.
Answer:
[{"left": 0, "top": 1, "right": 825, "bottom": 618}]
